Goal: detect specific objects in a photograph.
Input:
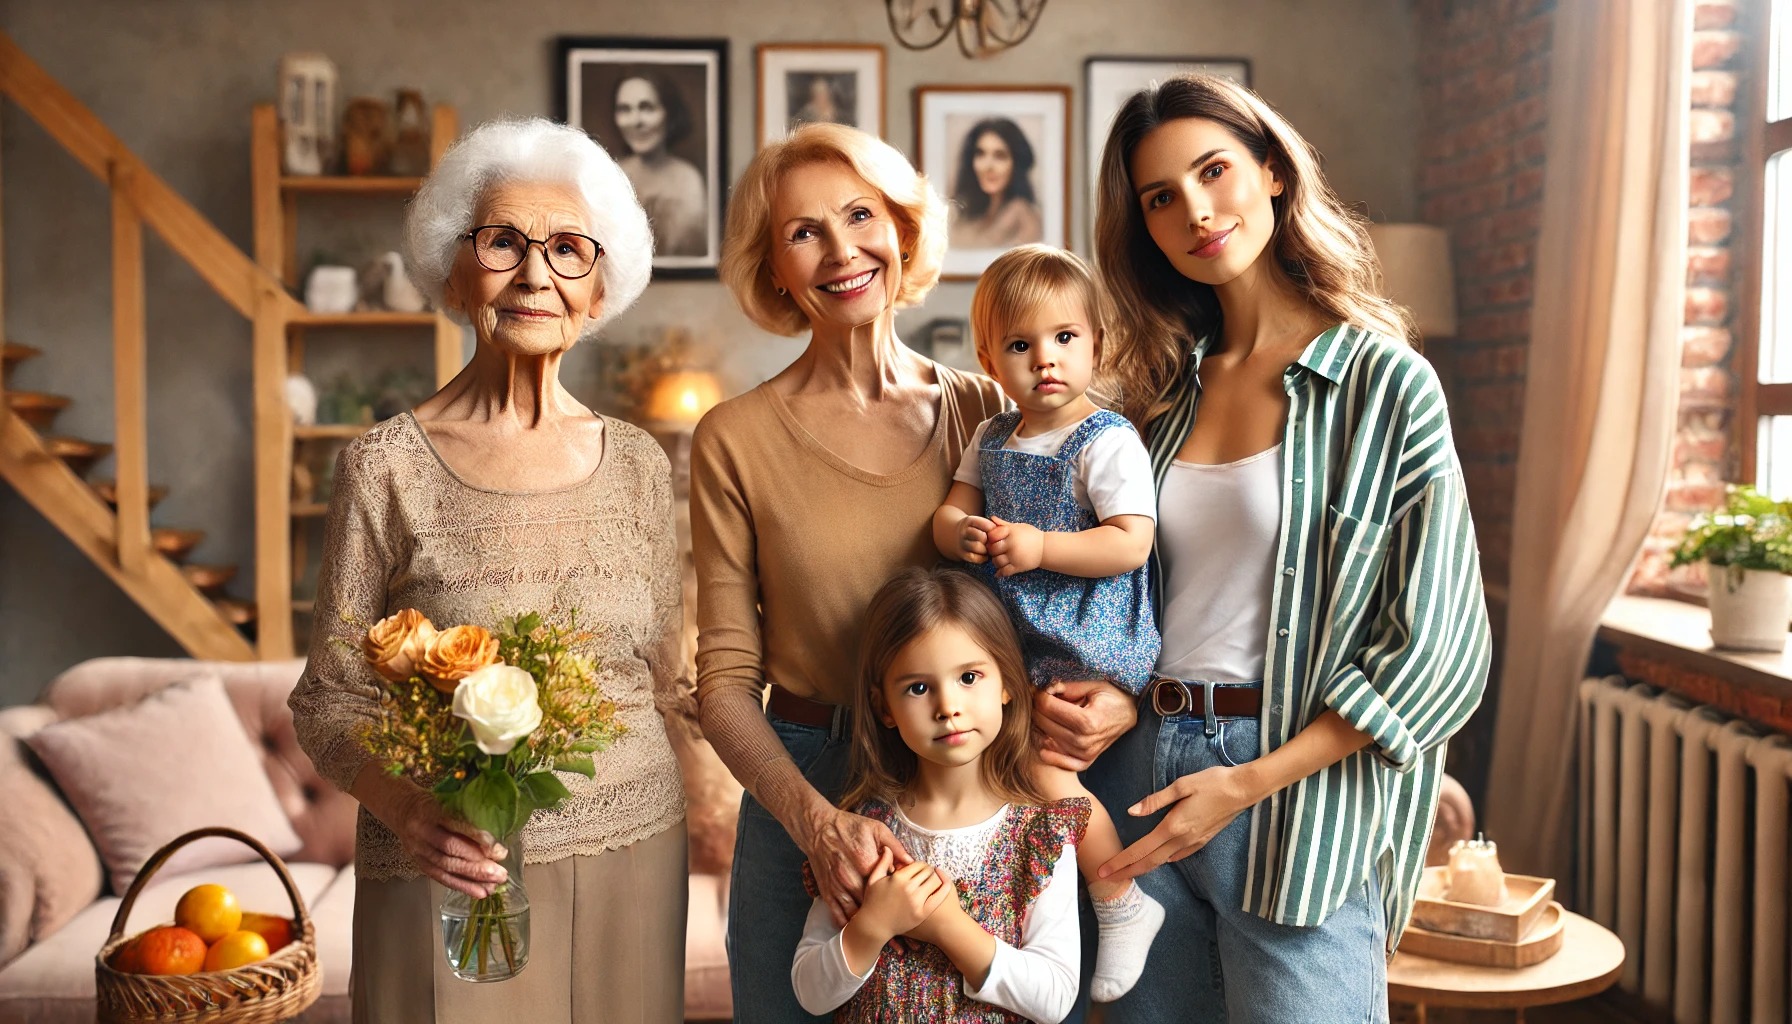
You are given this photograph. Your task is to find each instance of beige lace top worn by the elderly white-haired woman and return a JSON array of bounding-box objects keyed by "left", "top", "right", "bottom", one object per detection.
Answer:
[{"left": 289, "top": 412, "right": 692, "bottom": 881}]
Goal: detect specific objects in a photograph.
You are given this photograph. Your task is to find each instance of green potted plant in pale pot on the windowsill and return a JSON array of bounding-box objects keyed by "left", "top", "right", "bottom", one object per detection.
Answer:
[{"left": 1674, "top": 484, "right": 1792, "bottom": 651}]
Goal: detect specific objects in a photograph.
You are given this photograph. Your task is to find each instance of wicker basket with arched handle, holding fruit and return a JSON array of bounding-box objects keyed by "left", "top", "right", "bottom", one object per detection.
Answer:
[{"left": 93, "top": 829, "right": 323, "bottom": 1024}]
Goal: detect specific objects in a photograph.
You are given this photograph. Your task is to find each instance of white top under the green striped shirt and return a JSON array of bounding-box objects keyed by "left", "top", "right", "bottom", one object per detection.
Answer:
[{"left": 1158, "top": 445, "right": 1281, "bottom": 683}]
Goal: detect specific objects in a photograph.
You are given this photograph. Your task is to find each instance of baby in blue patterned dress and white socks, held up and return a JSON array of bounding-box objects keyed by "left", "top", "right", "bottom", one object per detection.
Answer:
[{"left": 934, "top": 246, "right": 1163, "bottom": 1002}]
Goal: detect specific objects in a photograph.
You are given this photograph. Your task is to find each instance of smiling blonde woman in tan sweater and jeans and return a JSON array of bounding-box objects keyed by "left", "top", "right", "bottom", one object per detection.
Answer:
[{"left": 692, "top": 124, "right": 1002, "bottom": 1024}]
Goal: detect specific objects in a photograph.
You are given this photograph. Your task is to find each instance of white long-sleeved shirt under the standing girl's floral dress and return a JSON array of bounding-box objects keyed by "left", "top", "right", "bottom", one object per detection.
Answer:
[{"left": 790, "top": 807, "right": 1082, "bottom": 1024}]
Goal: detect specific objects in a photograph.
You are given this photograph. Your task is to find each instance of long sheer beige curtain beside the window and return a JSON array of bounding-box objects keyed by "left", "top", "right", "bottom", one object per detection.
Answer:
[{"left": 1486, "top": 0, "right": 1692, "bottom": 879}]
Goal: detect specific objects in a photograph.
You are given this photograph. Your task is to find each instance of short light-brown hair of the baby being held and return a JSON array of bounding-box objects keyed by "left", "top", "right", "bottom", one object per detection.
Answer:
[{"left": 971, "top": 242, "right": 1107, "bottom": 377}]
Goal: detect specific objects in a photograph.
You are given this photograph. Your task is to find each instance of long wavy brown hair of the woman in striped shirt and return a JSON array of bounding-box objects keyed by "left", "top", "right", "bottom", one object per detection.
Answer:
[{"left": 1095, "top": 75, "right": 1417, "bottom": 427}]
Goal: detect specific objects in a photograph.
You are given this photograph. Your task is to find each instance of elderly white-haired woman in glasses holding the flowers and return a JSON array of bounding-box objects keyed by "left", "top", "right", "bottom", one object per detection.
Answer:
[{"left": 290, "top": 118, "right": 686, "bottom": 1024}]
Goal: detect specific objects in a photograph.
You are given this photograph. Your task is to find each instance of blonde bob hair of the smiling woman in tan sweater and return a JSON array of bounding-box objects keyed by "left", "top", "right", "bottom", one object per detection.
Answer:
[{"left": 717, "top": 124, "right": 946, "bottom": 337}]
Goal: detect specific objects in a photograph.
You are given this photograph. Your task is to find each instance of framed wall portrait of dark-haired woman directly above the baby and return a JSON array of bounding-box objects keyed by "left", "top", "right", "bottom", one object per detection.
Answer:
[{"left": 914, "top": 86, "right": 1070, "bottom": 280}]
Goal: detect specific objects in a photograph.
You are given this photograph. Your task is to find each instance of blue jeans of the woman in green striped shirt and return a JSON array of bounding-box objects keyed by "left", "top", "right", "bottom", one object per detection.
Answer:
[{"left": 1084, "top": 692, "right": 1387, "bottom": 1024}]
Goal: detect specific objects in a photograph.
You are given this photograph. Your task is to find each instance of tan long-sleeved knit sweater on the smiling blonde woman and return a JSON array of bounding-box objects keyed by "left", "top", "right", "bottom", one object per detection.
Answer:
[{"left": 690, "top": 364, "right": 1004, "bottom": 818}]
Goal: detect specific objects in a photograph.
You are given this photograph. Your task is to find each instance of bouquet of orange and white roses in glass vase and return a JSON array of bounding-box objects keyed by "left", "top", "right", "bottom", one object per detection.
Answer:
[{"left": 360, "top": 608, "right": 624, "bottom": 981}]
